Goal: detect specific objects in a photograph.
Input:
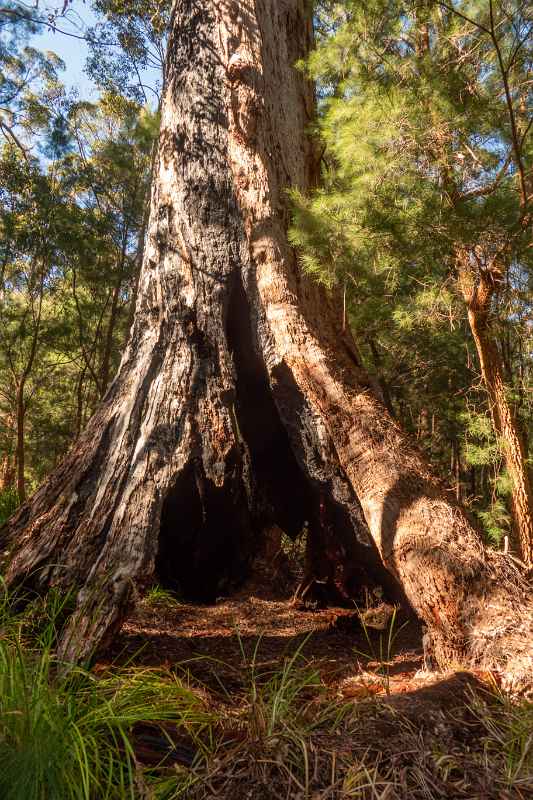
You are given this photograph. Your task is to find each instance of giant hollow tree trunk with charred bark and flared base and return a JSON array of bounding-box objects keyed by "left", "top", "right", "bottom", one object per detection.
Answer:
[{"left": 1, "top": 0, "right": 531, "bottom": 672}]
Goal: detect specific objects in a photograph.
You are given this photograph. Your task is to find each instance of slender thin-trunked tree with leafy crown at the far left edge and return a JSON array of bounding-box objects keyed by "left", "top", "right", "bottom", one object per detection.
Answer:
[{"left": 0, "top": 151, "right": 72, "bottom": 500}]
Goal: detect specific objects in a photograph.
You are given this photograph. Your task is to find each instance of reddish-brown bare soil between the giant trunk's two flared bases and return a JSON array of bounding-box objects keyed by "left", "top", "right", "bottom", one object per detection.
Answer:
[{"left": 108, "top": 556, "right": 426, "bottom": 696}]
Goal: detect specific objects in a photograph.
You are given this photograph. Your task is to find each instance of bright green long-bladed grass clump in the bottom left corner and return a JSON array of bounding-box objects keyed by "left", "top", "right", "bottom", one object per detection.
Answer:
[{"left": 0, "top": 580, "right": 209, "bottom": 800}]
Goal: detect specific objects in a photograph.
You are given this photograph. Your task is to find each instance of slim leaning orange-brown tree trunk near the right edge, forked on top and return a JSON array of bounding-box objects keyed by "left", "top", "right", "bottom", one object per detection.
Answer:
[{"left": 460, "top": 259, "right": 533, "bottom": 566}]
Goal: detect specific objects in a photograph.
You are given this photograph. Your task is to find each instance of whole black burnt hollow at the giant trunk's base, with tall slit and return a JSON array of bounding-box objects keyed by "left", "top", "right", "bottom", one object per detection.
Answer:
[{"left": 156, "top": 274, "right": 402, "bottom": 603}]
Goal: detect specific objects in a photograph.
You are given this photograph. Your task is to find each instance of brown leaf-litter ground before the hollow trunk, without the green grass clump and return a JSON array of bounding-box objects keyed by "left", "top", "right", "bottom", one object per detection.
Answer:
[{"left": 92, "top": 570, "right": 533, "bottom": 800}]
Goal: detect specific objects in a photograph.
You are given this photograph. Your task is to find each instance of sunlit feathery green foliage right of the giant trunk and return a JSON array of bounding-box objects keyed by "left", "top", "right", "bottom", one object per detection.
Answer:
[{"left": 291, "top": 0, "right": 533, "bottom": 540}]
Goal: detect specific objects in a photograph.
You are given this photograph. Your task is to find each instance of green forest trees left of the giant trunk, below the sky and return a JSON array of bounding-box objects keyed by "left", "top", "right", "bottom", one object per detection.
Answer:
[{"left": 0, "top": 78, "right": 159, "bottom": 487}]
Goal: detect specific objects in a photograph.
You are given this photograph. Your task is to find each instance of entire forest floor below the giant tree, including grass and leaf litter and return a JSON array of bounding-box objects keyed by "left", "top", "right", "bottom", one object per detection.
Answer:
[{"left": 0, "top": 562, "right": 533, "bottom": 800}]
